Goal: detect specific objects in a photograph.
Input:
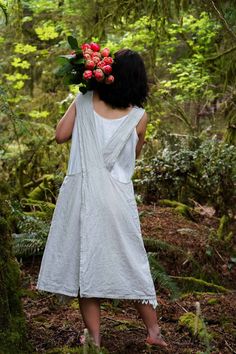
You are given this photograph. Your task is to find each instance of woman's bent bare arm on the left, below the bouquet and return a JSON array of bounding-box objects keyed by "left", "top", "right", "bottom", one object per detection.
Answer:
[{"left": 55, "top": 100, "right": 76, "bottom": 144}]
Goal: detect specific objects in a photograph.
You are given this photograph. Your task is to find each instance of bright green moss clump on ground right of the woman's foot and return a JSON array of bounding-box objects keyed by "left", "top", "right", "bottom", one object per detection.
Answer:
[{"left": 178, "top": 312, "right": 213, "bottom": 343}]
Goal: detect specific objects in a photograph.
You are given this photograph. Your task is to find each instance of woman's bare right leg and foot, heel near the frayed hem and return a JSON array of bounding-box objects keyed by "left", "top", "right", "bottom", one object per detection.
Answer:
[{"left": 134, "top": 301, "right": 167, "bottom": 347}]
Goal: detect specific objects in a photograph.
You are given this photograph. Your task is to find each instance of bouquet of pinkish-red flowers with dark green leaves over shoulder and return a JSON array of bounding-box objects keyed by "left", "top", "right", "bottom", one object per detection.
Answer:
[{"left": 56, "top": 36, "right": 114, "bottom": 93}]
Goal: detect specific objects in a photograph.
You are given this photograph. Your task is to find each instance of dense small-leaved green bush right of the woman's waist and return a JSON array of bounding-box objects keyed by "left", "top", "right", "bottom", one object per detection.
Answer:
[{"left": 134, "top": 139, "right": 236, "bottom": 215}]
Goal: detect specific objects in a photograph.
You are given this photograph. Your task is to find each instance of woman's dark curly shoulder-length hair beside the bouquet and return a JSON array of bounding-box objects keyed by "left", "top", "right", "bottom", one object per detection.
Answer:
[{"left": 90, "top": 49, "right": 148, "bottom": 108}]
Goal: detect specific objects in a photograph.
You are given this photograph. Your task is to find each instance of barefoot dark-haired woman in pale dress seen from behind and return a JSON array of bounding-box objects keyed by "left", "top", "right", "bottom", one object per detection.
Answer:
[{"left": 37, "top": 49, "right": 167, "bottom": 347}]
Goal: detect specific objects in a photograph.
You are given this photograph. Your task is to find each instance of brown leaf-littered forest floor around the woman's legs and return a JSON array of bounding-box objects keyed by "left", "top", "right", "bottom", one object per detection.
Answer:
[{"left": 21, "top": 206, "right": 236, "bottom": 354}]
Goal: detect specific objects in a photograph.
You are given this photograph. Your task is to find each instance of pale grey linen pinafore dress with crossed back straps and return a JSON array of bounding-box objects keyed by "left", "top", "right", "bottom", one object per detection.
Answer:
[{"left": 36, "top": 91, "right": 157, "bottom": 308}]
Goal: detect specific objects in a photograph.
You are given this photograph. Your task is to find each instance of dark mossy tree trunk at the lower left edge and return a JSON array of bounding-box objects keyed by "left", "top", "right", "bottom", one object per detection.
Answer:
[{"left": 0, "top": 217, "right": 31, "bottom": 354}]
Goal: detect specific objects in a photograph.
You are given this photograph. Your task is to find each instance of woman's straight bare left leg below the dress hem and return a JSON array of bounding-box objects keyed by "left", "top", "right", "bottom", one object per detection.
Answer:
[{"left": 79, "top": 297, "right": 101, "bottom": 347}]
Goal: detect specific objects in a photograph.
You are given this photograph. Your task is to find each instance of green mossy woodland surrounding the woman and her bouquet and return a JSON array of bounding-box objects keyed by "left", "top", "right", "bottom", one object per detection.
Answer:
[{"left": 0, "top": 0, "right": 236, "bottom": 354}]
